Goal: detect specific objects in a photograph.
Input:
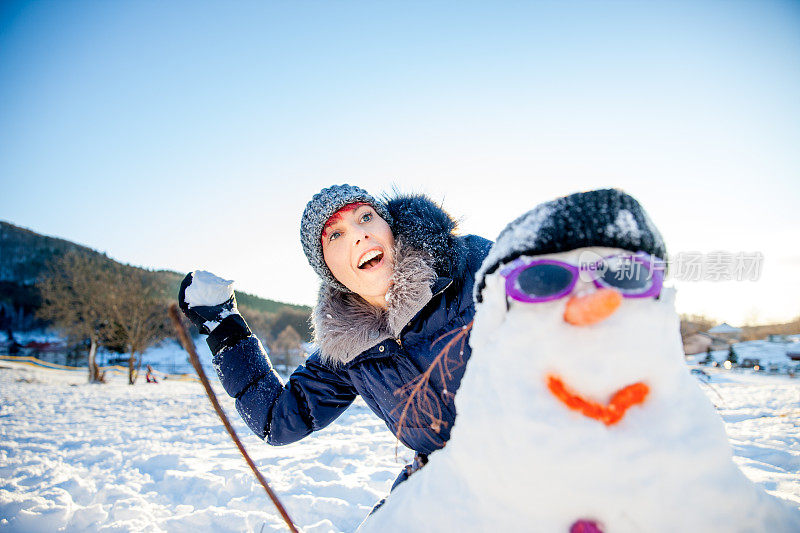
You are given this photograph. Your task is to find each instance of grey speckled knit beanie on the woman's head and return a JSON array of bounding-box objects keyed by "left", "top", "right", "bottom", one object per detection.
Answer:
[{"left": 300, "top": 184, "right": 393, "bottom": 292}]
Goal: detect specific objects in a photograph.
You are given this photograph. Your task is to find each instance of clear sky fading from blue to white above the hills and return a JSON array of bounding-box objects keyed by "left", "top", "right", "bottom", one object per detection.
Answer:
[{"left": 0, "top": 1, "right": 800, "bottom": 323}]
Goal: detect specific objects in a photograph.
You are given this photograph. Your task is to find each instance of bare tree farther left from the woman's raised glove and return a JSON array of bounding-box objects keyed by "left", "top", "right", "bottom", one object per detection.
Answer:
[{"left": 36, "top": 250, "right": 111, "bottom": 383}]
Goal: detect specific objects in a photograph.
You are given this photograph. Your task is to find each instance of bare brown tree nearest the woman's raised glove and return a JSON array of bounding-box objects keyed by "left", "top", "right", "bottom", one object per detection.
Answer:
[{"left": 104, "top": 267, "right": 168, "bottom": 385}]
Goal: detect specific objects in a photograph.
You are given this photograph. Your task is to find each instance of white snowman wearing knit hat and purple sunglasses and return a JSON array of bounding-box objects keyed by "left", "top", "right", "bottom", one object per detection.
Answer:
[{"left": 361, "top": 189, "right": 800, "bottom": 533}]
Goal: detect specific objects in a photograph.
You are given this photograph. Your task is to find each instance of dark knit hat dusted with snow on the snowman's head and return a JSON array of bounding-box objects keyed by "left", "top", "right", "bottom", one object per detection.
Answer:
[{"left": 474, "top": 189, "right": 667, "bottom": 302}]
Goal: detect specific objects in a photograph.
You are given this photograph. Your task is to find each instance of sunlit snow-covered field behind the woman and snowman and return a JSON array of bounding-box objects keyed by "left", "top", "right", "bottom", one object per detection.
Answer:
[{"left": 0, "top": 361, "right": 800, "bottom": 533}]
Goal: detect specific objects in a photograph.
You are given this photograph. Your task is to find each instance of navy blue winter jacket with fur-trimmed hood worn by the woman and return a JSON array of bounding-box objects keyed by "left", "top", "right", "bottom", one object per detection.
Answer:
[{"left": 209, "top": 196, "right": 491, "bottom": 454}]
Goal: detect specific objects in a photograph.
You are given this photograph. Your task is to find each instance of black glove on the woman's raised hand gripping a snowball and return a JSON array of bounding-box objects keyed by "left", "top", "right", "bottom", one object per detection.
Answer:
[{"left": 178, "top": 272, "right": 251, "bottom": 355}]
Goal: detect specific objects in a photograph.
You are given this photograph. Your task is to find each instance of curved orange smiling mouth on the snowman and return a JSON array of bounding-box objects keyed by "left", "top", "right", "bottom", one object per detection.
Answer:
[{"left": 547, "top": 375, "right": 650, "bottom": 426}]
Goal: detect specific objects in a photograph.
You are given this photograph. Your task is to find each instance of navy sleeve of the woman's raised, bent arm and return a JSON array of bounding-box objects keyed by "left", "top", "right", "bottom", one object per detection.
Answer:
[{"left": 213, "top": 335, "right": 357, "bottom": 445}]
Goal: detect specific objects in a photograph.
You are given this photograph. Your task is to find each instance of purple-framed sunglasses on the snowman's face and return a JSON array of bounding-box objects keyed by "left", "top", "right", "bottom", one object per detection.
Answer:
[{"left": 500, "top": 252, "right": 664, "bottom": 303}]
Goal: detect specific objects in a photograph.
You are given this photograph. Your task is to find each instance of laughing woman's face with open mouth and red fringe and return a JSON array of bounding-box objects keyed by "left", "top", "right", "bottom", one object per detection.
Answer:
[{"left": 322, "top": 205, "right": 394, "bottom": 308}]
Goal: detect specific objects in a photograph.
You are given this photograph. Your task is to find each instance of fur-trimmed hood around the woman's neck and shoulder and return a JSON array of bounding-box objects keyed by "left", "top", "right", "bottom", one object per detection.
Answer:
[{"left": 312, "top": 195, "right": 466, "bottom": 364}]
